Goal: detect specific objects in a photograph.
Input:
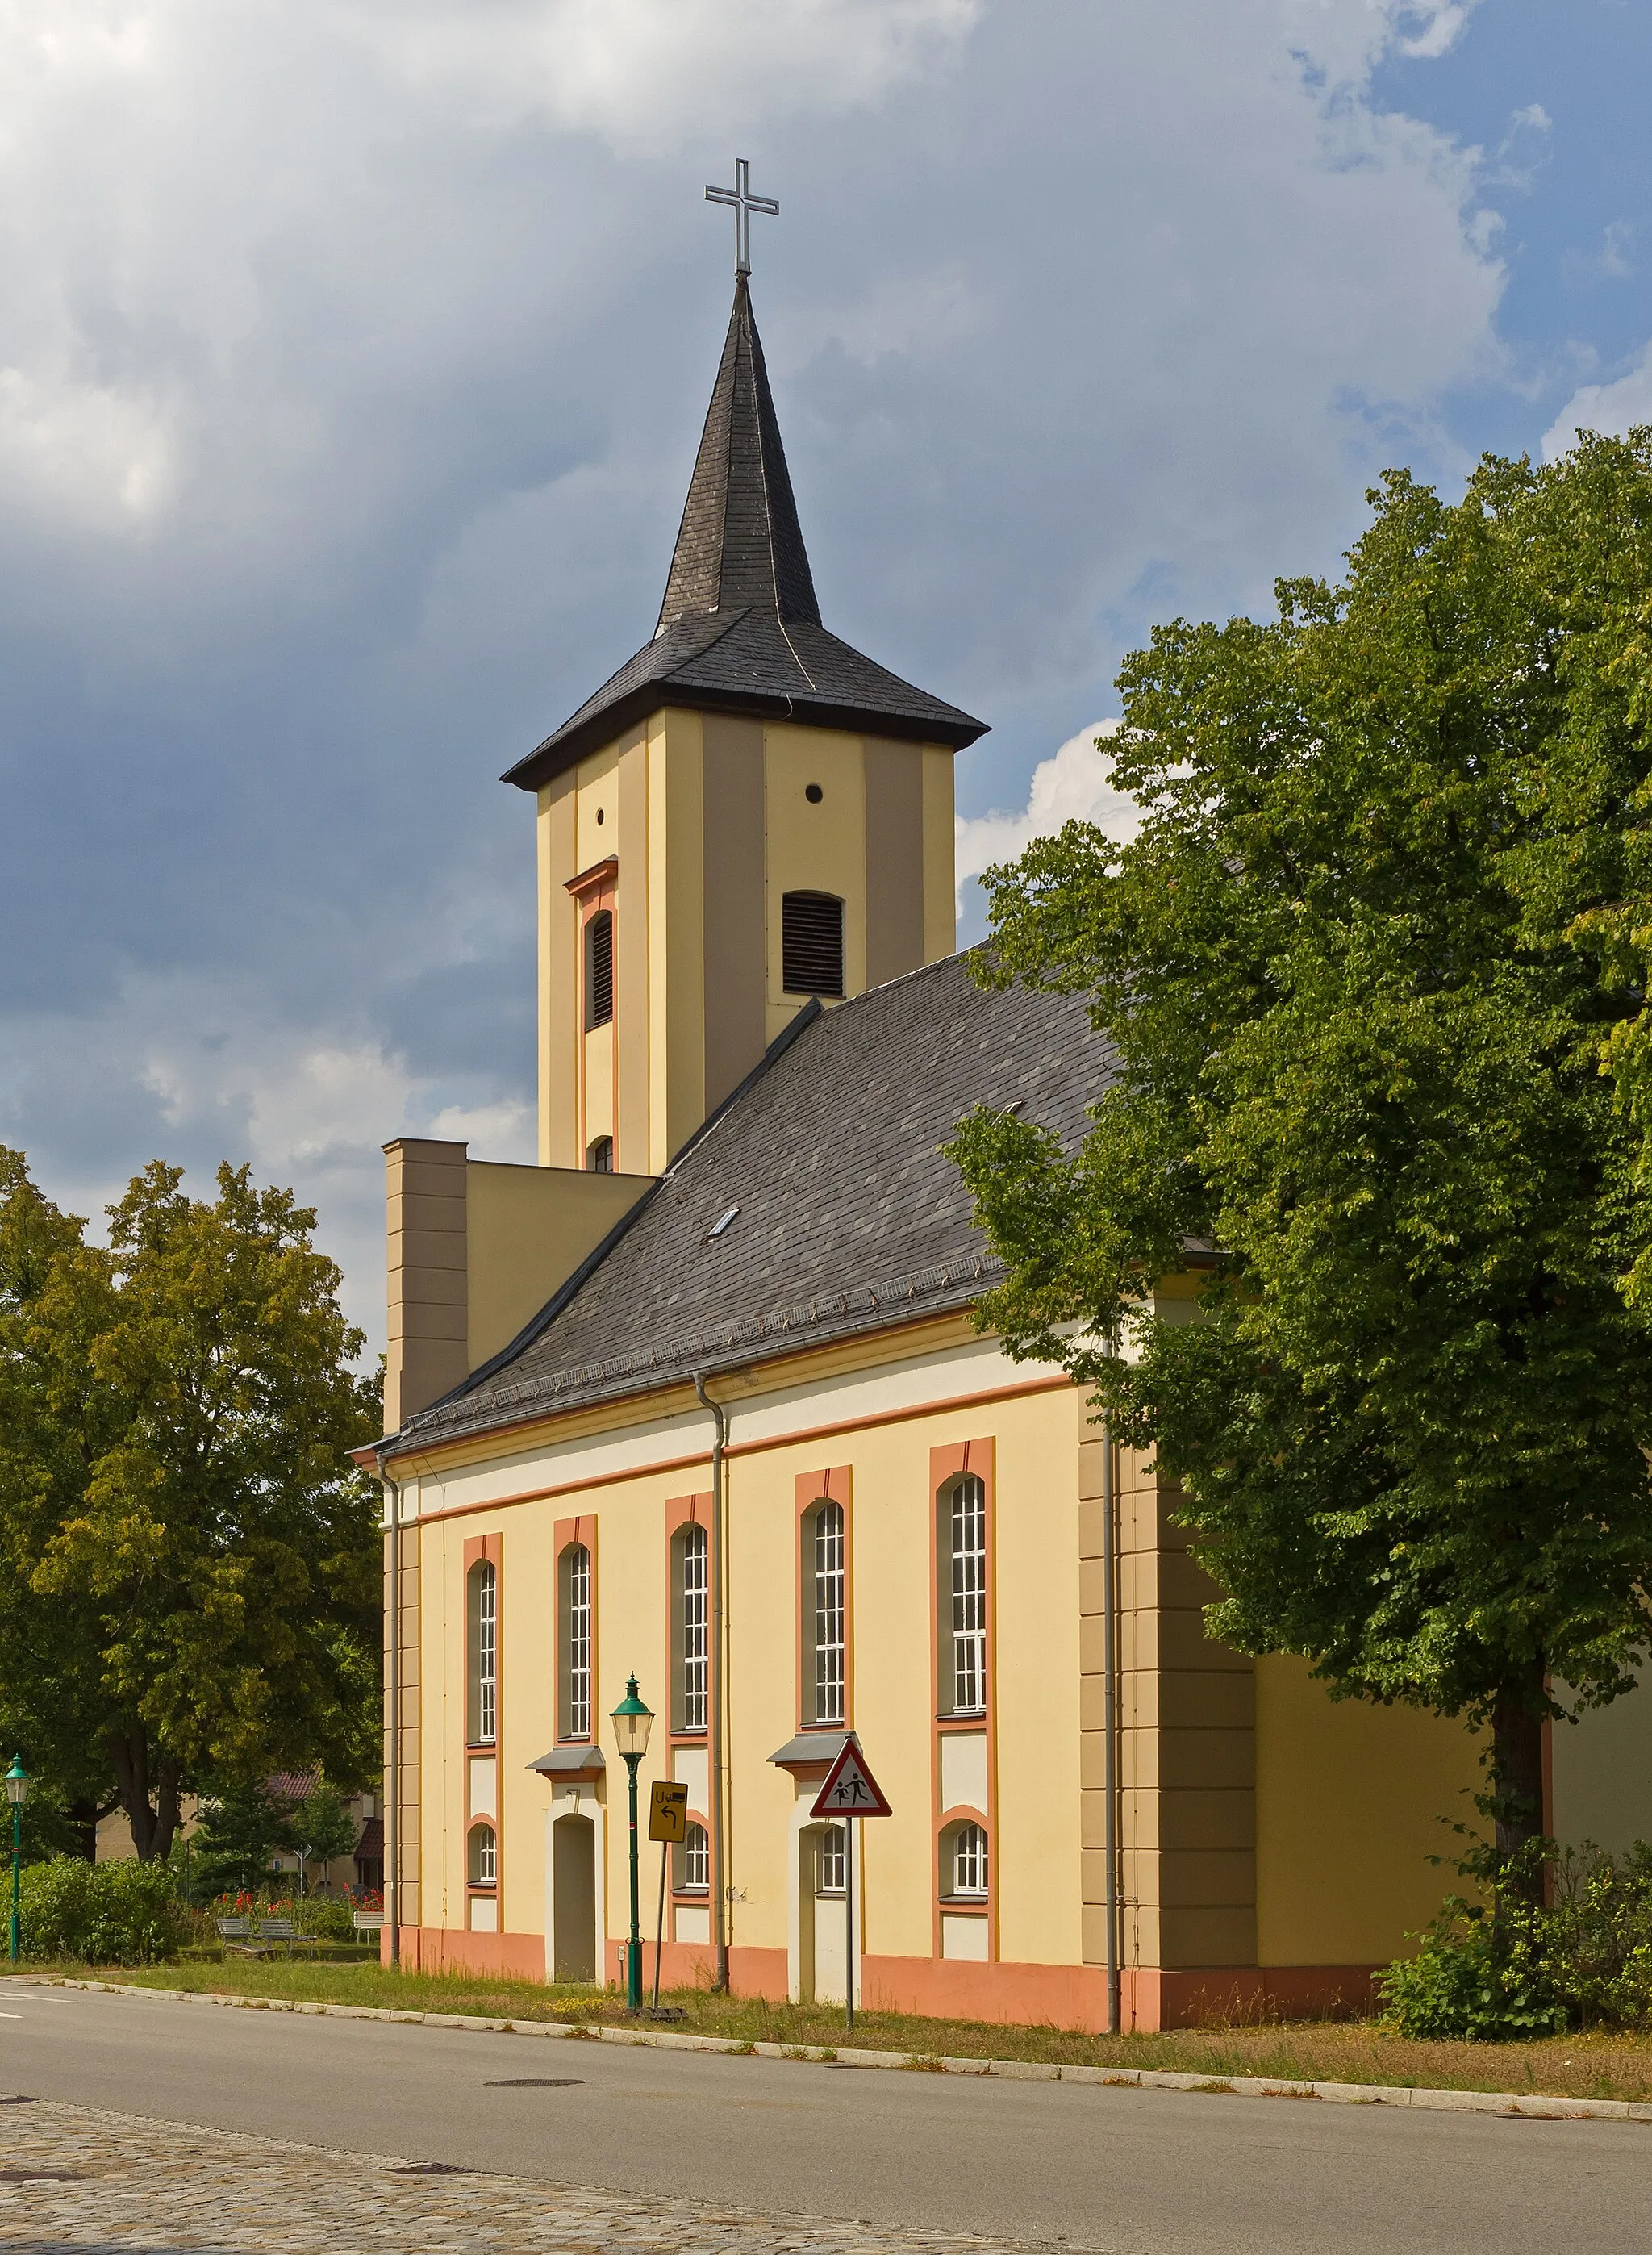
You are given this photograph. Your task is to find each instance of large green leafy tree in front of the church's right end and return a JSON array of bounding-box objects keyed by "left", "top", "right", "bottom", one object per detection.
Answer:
[{"left": 953, "top": 431, "right": 1652, "bottom": 1872}]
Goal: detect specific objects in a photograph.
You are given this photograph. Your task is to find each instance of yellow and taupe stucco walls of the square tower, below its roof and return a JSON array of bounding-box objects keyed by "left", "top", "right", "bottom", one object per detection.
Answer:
[{"left": 539, "top": 706, "right": 953, "bottom": 1172}]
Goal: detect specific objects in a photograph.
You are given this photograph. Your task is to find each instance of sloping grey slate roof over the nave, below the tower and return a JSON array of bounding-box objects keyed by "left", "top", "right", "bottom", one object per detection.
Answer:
[{"left": 387, "top": 956, "right": 1111, "bottom": 1446}]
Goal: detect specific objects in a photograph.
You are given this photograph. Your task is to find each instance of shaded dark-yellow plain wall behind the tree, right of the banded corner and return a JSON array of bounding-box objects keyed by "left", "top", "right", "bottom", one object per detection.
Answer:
[{"left": 1255, "top": 1656, "right": 1481, "bottom": 1966}]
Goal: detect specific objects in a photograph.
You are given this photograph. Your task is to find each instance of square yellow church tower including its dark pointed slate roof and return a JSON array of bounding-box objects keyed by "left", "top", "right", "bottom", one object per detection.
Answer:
[{"left": 505, "top": 273, "right": 985, "bottom": 1175}]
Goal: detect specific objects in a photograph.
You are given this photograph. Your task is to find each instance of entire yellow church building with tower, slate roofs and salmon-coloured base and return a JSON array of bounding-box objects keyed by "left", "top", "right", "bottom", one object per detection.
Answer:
[{"left": 365, "top": 242, "right": 1622, "bottom": 2030}]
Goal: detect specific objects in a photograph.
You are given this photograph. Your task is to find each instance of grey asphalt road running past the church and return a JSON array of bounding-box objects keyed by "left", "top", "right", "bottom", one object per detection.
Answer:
[{"left": 0, "top": 1985, "right": 1652, "bottom": 2255}]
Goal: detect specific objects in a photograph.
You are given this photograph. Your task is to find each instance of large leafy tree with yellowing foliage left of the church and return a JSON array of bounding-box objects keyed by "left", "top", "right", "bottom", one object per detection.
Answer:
[{"left": 0, "top": 1152, "right": 378, "bottom": 1856}]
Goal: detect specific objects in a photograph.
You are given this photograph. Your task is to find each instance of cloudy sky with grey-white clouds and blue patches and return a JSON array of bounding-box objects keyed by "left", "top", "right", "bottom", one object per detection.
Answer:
[{"left": 0, "top": 0, "right": 1652, "bottom": 1337}]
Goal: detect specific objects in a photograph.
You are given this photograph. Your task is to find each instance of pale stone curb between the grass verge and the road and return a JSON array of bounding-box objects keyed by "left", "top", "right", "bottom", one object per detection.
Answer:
[{"left": 11, "top": 1973, "right": 1652, "bottom": 2122}]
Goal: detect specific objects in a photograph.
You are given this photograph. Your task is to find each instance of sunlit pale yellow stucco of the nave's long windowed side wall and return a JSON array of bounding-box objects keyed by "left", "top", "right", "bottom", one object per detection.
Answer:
[{"left": 403, "top": 1342, "right": 1082, "bottom": 1964}]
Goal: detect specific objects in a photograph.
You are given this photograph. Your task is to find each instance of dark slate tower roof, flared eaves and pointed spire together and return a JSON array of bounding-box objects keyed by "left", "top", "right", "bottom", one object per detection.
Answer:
[{"left": 503, "top": 275, "right": 985, "bottom": 791}]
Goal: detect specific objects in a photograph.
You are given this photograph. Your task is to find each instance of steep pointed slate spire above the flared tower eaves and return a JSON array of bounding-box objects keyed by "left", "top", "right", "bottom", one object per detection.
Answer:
[{"left": 653, "top": 275, "right": 820, "bottom": 636}]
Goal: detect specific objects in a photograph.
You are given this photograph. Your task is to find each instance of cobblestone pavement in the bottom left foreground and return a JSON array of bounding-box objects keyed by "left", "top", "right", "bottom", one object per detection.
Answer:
[{"left": 0, "top": 2099, "right": 1045, "bottom": 2255}]
